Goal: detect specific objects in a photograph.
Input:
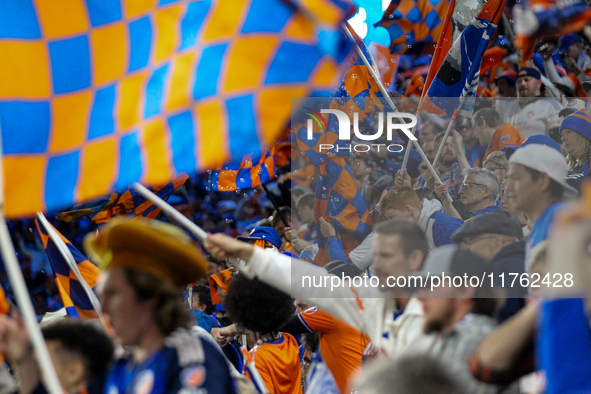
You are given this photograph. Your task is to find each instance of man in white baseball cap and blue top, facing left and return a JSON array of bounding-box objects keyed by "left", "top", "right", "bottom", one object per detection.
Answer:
[{"left": 505, "top": 144, "right": 577, "bottom": 267}]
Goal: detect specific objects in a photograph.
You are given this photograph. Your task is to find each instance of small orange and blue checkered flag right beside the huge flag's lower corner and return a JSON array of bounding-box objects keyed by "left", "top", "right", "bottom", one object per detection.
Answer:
[{"left": 208, "top": 147, "right": 276, "bottom": 192}]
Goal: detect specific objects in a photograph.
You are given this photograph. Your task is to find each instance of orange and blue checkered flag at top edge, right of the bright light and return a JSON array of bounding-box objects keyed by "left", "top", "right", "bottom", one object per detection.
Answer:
[{"left": 374, "top": 0, "right": 449, "bottom": 54}]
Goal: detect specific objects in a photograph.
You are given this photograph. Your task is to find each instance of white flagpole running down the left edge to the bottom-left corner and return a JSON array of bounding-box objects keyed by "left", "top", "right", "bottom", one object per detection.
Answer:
[{"left": 0, "top": 130, "right": 64, "bottom": 394}]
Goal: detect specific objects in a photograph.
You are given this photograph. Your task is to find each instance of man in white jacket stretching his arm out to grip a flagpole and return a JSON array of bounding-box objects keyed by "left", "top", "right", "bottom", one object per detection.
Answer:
[{"left": 205, "top": 220, "right": 432, "bottom": 358}]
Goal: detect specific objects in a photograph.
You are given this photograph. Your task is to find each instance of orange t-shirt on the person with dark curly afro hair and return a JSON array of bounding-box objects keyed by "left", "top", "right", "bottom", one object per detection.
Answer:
[{"left": 250, "top": 333, "right": 302, "bottom": 394}]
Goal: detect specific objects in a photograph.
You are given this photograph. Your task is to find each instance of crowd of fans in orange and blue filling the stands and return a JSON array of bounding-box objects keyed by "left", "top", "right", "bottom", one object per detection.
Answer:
[{"left": 0, "top": 6, "right": 591, "bottom": 394}]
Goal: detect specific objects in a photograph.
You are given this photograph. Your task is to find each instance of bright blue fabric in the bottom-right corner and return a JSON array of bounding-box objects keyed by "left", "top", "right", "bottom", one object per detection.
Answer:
[{"left": 537, "top": 298, "right": 591, "bottom": 394}]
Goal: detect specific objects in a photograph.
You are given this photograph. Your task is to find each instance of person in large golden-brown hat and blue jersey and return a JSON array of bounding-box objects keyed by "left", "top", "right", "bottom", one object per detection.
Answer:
[{"left": 6, "top": 219, "right": 236, "bottom": 394}]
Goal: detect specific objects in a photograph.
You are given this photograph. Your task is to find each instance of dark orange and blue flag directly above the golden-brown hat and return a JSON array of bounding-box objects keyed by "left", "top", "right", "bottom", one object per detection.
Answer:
[{"left": 57, "top": 174, "right": 189, "bottom": 224}]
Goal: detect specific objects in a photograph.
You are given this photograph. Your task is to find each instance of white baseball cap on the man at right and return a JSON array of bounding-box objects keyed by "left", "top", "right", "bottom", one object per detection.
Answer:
[{"left": 509, "top": 144, "right": 578, "bottom": 194}]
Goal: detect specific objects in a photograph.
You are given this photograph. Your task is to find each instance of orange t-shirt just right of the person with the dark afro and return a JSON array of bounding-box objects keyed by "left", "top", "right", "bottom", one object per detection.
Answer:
[{"left": 298, "top": 307, "right": 370, "bottom": 393}]
